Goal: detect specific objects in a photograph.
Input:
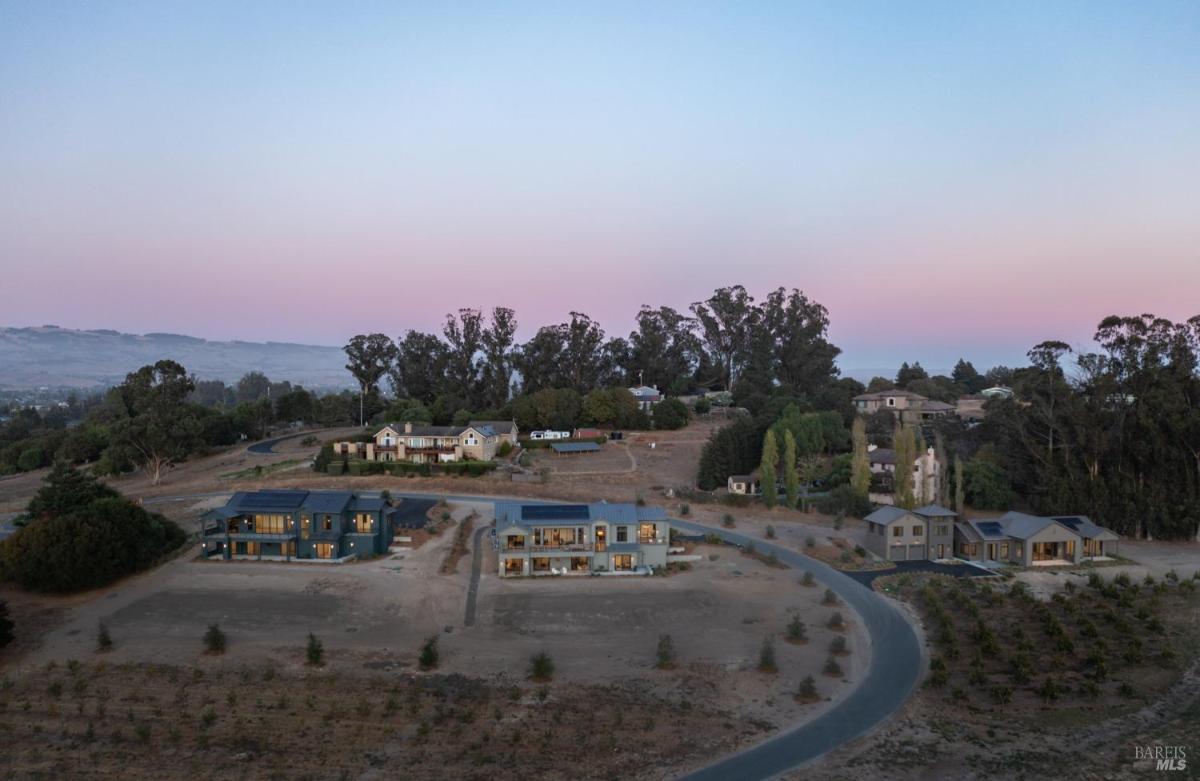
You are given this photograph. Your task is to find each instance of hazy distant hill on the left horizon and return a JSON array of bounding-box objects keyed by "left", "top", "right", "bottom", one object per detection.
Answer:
[{"left": 0, "top": 325, "right": 353, "bottom": 390}]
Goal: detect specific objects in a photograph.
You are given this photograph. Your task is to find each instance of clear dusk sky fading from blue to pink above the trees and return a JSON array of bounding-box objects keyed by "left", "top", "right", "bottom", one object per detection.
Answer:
[{"left": 0, "top": 0, "right": 1200, "bottom": 370}]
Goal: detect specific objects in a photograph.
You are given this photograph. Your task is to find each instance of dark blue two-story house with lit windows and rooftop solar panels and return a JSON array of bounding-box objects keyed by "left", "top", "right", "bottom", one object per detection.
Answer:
[{"left": 200, "top": 491, "right": 396, "bottom": 561}]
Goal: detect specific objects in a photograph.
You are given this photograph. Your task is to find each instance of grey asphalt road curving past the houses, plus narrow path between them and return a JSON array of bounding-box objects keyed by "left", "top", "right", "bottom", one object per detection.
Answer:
[{"left": 150, "top": 489, "right": 924, "bottom": 781}]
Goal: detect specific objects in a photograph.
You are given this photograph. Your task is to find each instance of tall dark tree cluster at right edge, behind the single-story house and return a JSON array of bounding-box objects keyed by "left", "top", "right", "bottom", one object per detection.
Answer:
[{"left": 984, "top": 314, "right": 1200, "bottom": 539}]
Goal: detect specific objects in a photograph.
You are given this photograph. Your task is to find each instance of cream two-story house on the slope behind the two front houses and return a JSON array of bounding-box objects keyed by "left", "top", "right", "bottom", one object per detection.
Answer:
[{"left": 334, "top": 422, "right": 501, "bottom": 464}]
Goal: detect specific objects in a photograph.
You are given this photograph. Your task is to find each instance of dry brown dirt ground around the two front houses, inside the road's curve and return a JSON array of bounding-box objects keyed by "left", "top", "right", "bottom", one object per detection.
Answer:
[{"left": 0, "top": 417, "right": 870, "bottom": 777}]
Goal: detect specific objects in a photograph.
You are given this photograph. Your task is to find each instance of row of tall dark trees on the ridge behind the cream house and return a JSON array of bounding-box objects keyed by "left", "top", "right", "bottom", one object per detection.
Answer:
[{"left": 344, "top": 286, "right": 844, "bottom": 421}]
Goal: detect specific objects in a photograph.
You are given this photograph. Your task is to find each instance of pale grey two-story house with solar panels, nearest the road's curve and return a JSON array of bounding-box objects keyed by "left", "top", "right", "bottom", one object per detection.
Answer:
[{"left": 496, "top": 501, "right": 671, "bottom": 577}]
